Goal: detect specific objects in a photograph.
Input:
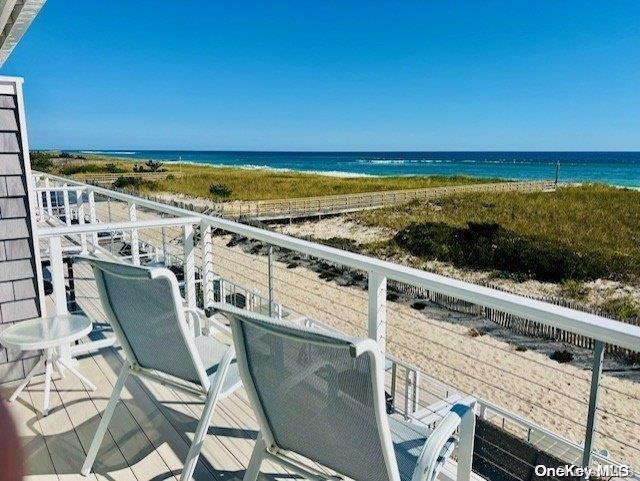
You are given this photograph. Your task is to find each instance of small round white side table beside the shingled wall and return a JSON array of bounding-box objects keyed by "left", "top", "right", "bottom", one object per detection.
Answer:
[{"left": 0, "top": 314, "right": 96, "bottom": 416}]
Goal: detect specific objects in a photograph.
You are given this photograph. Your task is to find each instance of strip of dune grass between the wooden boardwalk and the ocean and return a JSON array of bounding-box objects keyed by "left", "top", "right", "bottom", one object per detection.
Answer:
[{"left": 42, "top": 156, "right": 499, "bottom": 200}]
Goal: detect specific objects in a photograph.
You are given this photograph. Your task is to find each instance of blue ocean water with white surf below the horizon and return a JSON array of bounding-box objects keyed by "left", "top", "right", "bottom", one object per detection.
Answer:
[{"left": 76, "top": 150, "right": 640, "bottom": 187}]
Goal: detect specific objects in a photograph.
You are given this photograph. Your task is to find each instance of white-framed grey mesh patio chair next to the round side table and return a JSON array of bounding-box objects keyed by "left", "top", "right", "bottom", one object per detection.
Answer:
[{"left": 79, "top": 257, "right": 241, "bottom": 481}]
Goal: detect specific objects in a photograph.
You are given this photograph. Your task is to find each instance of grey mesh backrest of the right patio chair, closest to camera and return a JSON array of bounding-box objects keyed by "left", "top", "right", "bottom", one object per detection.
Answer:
[{"left": 220, "top": 305, "right": 399, "bottom": 481}]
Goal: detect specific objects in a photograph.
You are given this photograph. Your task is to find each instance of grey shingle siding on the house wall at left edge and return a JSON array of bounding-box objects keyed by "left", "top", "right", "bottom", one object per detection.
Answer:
[{"left": 0, "top": 91, "right": 40, "bottom": 384}]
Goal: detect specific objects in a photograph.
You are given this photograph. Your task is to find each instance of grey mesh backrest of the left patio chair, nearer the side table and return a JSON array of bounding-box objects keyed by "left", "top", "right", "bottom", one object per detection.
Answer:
[{"left": 80, "top": 257, "right": 210, "bottom": 390}]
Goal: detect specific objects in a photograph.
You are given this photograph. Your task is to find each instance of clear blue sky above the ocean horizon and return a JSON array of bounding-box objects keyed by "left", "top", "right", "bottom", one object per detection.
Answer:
[{"left": 0, "top": 0, "right": 640, "bottom": 150}]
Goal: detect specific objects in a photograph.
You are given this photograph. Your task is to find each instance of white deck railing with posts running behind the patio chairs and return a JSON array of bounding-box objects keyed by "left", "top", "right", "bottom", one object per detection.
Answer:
[{"left": 35, "top": 173, "right": 640, "bottom": 476}]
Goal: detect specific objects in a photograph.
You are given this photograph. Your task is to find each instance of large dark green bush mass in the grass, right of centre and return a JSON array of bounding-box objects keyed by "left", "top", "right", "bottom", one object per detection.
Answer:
[{"left": 395, "top": 222, "right": 611, "bottom": 282}]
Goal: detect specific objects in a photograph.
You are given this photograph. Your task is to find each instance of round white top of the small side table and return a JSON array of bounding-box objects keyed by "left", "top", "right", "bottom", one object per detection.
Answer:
[{"left": 0, "top": 314, "right": 92, "bottom": 351}]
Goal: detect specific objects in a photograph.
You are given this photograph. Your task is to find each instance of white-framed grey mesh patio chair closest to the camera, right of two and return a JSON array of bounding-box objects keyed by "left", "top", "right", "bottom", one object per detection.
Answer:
[{"left": 214, "top": 304, "right": 475, "bottom": 481}]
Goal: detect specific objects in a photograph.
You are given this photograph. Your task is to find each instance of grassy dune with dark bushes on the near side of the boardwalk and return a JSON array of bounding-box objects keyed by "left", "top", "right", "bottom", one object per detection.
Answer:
[{"left": 354, "top": 185, "right": 640, "bottom": 282}]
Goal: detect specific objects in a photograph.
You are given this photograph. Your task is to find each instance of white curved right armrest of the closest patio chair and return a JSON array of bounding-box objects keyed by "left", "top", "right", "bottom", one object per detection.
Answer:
[{"left": 411, "top": 398, "right": 475, "bottom": 481}]
